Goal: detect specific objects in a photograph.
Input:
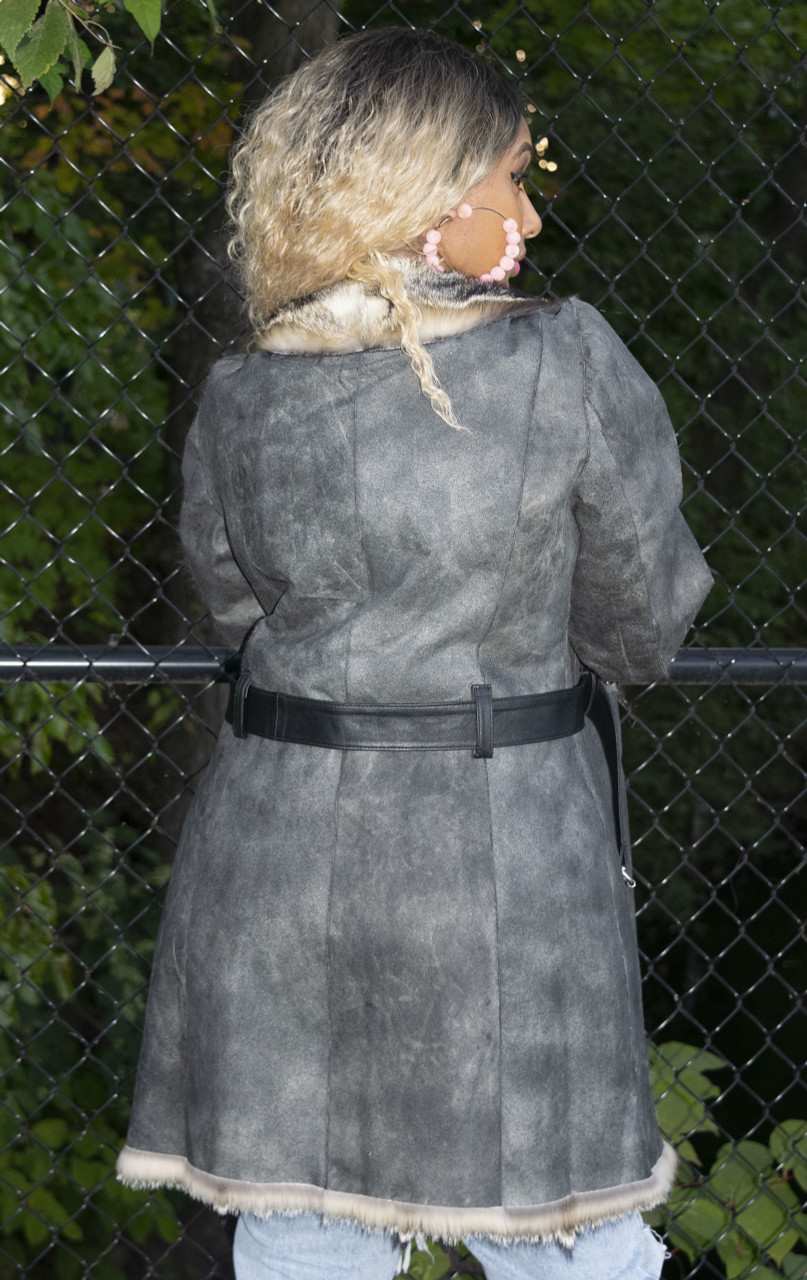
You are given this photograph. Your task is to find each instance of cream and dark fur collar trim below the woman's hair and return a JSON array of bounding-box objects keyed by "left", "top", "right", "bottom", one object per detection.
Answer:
[{"left": 257, "top": 259, "right": 546, "bottom": 355}]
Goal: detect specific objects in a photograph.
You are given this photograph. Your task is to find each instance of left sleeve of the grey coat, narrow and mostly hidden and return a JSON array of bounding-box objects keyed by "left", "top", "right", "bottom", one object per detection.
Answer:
[{"left": 179, "top": 361, "right": 264, "bottom": 649}]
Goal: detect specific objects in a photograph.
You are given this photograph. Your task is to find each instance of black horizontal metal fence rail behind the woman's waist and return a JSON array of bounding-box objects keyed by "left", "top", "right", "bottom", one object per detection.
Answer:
[{"left": 0, "top": 645, "right": 807, "bottom": 685}]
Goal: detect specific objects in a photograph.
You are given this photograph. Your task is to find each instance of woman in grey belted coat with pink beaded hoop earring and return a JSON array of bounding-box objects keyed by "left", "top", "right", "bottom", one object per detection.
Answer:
[{"left": 118, "top": 28, "right": 711, "bottom": 1280}]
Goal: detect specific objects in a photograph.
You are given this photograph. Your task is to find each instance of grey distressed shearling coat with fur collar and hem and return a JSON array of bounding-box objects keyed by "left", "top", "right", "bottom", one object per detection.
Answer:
[{"left": 118, "top": 266, "right": 711, "bottom": 1240}]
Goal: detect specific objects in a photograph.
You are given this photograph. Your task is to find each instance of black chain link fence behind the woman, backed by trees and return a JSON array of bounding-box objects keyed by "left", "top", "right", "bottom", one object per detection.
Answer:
[{"left": 0, "top": 0, "right": 807, "bottom": 1280}]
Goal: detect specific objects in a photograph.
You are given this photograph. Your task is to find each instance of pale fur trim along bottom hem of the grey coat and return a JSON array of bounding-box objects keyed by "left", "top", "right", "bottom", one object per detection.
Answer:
[{"left": 115, "top": 1142, "right": 678, "bottom": 1247}]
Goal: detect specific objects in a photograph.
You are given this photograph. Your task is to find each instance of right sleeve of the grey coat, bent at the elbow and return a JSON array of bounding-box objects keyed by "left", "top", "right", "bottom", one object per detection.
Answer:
[{"left": 569, "top": 301, "right": 712, "bottom": 684}]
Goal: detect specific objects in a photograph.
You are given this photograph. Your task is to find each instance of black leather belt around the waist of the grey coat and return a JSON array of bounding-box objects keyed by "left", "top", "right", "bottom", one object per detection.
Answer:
[{"left": 227, "top": 669, "right": 635, "bottom": 887}]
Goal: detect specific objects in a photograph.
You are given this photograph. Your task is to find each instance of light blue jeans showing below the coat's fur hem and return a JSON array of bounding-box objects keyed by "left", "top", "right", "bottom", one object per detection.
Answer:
[{"left": 233, "top": 1212, "right": 665, "bottom": 1280}]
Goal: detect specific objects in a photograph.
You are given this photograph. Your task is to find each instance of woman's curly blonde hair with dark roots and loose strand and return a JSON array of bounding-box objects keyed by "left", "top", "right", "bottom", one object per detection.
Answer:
[{"left": 227, "top": 27, "right": 523, "bottom": 426}]
